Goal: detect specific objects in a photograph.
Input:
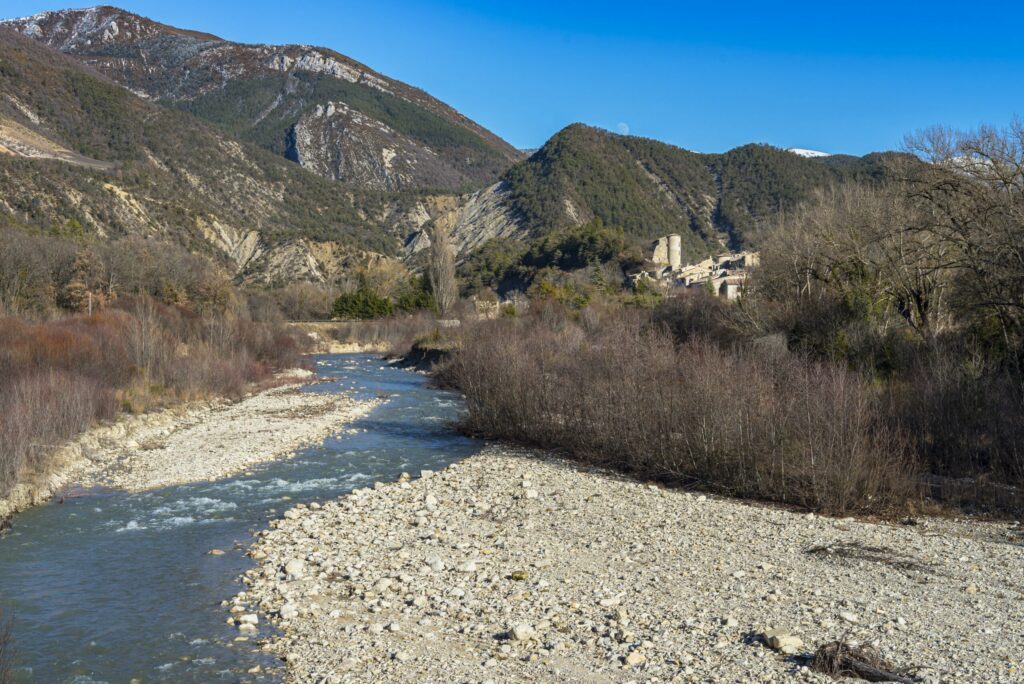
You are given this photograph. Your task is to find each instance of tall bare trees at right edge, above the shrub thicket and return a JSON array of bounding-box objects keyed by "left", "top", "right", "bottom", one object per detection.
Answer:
[{"left": 757, "top": 120, "right": 1024, "bottom": 354}]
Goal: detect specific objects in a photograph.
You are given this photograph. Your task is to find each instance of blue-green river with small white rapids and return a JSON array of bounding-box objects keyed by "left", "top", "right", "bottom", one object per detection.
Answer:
[{"left": 0, "top": 354, "right": 479, "bottom": 684}]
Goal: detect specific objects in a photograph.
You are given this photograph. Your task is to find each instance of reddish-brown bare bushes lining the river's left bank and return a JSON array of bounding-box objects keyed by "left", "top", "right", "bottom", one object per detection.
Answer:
[{"left": 0, "top": 297, "right": 308, "bottom": 496}]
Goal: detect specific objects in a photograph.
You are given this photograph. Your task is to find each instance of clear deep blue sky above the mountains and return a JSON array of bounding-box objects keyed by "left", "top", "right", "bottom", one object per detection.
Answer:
[{"left": 0, "top": 0, "right": 1024, "bottom": 155}]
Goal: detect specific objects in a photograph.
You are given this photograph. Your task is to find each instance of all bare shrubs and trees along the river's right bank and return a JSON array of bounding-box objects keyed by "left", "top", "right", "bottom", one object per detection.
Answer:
[{"left": 430, "top": 122, "right": 1024, "bottom": 514}]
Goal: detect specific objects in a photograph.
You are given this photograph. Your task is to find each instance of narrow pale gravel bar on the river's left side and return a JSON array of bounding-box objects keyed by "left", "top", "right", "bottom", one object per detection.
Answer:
[{"left": 0, "top": 369, "right": 379, "bottom": 519}]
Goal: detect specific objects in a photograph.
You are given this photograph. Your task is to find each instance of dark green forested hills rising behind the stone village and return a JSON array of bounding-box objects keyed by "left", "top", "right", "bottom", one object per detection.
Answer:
[{"left": 483, "top": 124, "right": 901, "bottom": 256}]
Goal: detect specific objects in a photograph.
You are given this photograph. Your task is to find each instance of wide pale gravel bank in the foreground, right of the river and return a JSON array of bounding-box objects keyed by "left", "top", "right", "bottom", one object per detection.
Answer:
[{"left": 230, "top": 446, "right": 1024, "bottom": 682}]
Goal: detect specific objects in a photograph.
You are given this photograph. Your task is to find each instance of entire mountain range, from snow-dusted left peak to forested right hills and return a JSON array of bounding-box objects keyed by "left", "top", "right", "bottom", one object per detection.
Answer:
[{"left": 0, "top": 6, "right": 901, "bottom": 285}]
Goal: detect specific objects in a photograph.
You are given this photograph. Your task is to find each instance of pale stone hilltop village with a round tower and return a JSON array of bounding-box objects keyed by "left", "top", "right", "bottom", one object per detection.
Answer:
[{"left": 633, "top": 234, "right": 759, "bottom": 300}]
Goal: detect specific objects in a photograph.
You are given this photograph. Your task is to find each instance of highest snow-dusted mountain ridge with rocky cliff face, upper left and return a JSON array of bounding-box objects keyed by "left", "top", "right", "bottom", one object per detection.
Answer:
[{"left": 0, "top": 6, "right": 521, "bottom": 191}]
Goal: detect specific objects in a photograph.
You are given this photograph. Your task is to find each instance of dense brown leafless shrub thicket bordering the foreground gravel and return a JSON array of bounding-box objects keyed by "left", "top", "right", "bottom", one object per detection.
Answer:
[{"left": 445, "top": 310, "right": 915, "bottom": 513}]
